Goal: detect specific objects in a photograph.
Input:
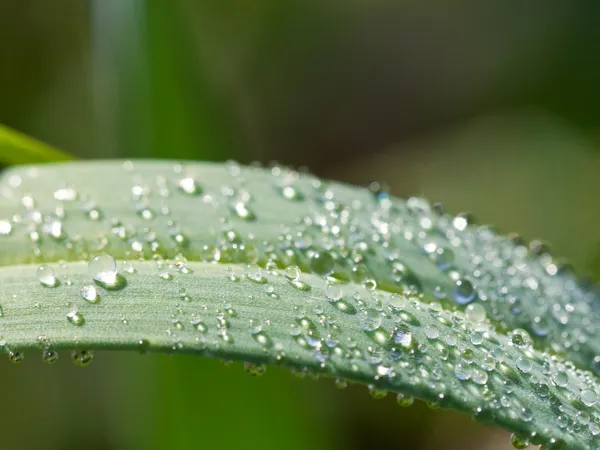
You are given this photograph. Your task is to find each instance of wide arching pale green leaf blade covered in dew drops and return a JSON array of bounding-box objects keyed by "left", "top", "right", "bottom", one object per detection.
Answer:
[{"left": 0, "top": 161, "right": 600, "bottom": 449}]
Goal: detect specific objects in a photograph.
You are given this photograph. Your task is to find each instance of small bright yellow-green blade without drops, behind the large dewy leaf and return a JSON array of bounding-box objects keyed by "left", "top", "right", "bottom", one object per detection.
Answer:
[{"left": 0, "top": 125, "right": 73, "bottom": 164}]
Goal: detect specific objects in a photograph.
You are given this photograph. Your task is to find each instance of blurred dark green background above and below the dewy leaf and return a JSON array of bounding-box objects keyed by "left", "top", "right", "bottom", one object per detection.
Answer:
[{"left": 0, "top": 0, "right": 600, "bottom": 450}]
